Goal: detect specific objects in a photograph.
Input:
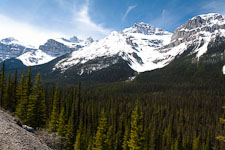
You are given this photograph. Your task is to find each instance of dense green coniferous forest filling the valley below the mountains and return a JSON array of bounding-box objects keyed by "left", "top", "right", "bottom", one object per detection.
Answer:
[{"left": 0, "top": 60, "right": 225, "bottom": 150}]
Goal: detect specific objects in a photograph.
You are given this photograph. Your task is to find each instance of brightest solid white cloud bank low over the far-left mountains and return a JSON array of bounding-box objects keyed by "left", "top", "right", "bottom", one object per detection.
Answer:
[{"left": 0, "top": 14, "right": 63, "bottom": 48}]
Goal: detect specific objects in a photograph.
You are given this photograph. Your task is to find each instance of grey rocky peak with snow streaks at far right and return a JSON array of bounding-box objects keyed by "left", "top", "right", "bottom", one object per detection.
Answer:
[{"left": 163, "top": 13, "right": 225, "bottom": 58}]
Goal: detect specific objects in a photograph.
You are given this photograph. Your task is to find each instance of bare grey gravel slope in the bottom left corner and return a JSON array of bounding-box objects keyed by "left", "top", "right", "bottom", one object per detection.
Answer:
[{"left": 0, "top": 110, "right": 51, "bottom": 150}]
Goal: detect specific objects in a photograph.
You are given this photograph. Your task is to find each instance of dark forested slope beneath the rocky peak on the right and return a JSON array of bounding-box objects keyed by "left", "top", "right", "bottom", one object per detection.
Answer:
[{"left": 135, "top": 34, "right": 225, "bottom": 84}]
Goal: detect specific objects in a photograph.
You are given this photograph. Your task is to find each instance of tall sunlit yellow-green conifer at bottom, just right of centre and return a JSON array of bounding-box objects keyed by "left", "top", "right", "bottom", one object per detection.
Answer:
[{"left": 128, "top": 104, "right": 144, "bottom": 150}]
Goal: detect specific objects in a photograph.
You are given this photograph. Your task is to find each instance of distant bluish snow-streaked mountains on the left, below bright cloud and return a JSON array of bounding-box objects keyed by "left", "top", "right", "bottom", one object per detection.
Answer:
[{"left": 0, "top": 36, "right": 94, "bottom": 66}]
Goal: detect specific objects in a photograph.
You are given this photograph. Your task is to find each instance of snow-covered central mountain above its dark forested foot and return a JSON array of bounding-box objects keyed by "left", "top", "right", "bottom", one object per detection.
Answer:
[{"left": 54, "top": 23, "right": 172, "bottom": 72}]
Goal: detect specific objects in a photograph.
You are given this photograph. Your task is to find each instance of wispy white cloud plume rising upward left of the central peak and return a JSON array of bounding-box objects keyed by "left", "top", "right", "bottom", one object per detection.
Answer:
[{"left": 73, "top": 1, "right": 112, "bottom": 39}]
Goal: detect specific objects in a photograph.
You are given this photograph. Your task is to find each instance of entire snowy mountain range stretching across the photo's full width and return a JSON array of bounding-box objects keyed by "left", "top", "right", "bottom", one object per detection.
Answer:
[{"left": 0, "top": 13, "right": 225, "bottom": 82}]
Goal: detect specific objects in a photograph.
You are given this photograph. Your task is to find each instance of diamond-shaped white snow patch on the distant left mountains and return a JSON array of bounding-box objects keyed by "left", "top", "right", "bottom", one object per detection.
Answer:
[{"left": 17, "top": 49, "right": 56, "bottom": 66}]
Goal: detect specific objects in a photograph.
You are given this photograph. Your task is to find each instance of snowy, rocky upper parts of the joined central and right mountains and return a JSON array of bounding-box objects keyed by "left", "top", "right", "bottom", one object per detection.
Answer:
[{"left": 53, "top": 13, "right": 225, "bottom": 79}]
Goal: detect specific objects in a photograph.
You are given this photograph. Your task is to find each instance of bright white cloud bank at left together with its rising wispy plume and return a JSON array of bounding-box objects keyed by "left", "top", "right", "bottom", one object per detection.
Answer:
[{"left": 0, "top": 0, "right": 112, "bottom": 48}]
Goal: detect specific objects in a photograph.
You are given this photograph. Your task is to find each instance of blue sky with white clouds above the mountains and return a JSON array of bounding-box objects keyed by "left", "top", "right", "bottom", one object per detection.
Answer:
[{"left": 0, "top": 0, "right": 225, "bottom": 44}]
